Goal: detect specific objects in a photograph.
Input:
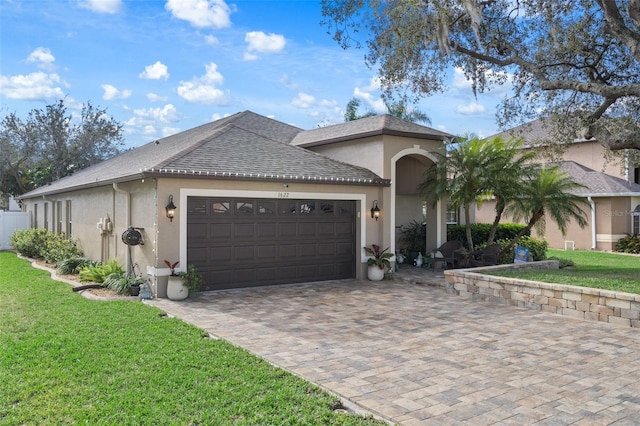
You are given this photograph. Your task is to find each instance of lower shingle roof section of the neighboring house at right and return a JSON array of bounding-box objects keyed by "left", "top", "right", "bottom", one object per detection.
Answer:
[{"left": 557, "top": 161, "right": 640, "bottom": 197}]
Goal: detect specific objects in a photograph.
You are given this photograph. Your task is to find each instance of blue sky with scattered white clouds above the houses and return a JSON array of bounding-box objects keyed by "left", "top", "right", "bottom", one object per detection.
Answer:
[{"left": 0, "top": 0, "right": 504, "bottom": 147}]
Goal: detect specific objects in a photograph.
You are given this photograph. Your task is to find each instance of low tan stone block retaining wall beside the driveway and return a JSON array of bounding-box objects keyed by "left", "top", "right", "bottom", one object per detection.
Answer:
[{"left": 444, "top": 260, "right": 640, "bottom": 327}]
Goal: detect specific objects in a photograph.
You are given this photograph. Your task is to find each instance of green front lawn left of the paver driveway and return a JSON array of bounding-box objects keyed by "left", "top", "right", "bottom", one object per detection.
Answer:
[{"left": 0, "top": 252, "right": 385, "bottom": 425}]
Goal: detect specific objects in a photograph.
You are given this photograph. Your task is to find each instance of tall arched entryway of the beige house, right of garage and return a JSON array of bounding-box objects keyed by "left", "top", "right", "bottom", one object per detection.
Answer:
[{"left": 389, "top": 147, "right": 446, "bottom": 262}]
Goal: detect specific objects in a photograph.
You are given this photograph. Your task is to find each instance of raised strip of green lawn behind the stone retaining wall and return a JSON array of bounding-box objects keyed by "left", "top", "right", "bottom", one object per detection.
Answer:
[{"left": 491, "top": 250, "right": 640, "bottom": 294}]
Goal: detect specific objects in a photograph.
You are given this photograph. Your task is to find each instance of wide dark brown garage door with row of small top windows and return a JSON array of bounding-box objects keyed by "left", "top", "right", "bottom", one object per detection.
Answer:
[{"left": 187, "top": 197, "right": 356, "bottom": 290}]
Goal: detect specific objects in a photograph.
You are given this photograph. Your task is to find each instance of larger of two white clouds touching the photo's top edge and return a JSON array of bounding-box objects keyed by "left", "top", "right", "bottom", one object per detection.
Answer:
[{"left": 164, "top": 0, "right": 233, "bottom": 28}]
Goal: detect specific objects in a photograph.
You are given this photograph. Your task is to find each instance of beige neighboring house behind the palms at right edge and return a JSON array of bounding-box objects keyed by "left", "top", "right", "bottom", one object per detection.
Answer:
[{"left": 475, "top": 120, "right": 640, "bottom": 251}]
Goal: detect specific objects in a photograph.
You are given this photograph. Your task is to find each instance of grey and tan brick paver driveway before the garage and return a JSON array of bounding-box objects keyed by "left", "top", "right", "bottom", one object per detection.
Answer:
[{"left": 150, "top": 280, "right": 640, "bottom": 425}]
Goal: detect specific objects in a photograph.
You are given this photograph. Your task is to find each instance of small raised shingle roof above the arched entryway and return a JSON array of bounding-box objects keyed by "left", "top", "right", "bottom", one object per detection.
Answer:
[{"left": 291, "top": 114, "right": 453, "bottom": 147}]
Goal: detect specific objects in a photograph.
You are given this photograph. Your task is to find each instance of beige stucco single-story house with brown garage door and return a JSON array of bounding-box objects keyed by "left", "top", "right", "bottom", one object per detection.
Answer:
[{"left": 21, "top": 111, "right": 450, "bottom": 289}]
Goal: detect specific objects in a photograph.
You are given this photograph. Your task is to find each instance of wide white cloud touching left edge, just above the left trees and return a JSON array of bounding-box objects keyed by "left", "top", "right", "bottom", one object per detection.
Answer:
[{"left": 0, "top": 71, "right": 66, "bottom": 100}]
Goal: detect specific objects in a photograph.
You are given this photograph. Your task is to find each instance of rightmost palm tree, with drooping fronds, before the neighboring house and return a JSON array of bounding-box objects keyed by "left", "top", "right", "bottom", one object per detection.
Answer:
[{"left": 506, "top": 167, "right": 588, "bottom": 250}]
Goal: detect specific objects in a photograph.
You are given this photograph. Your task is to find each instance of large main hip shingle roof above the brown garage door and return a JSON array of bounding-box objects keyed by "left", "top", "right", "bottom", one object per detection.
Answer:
[{"left": 20, "top": 111, "right": 388, "bottom": 198}]
